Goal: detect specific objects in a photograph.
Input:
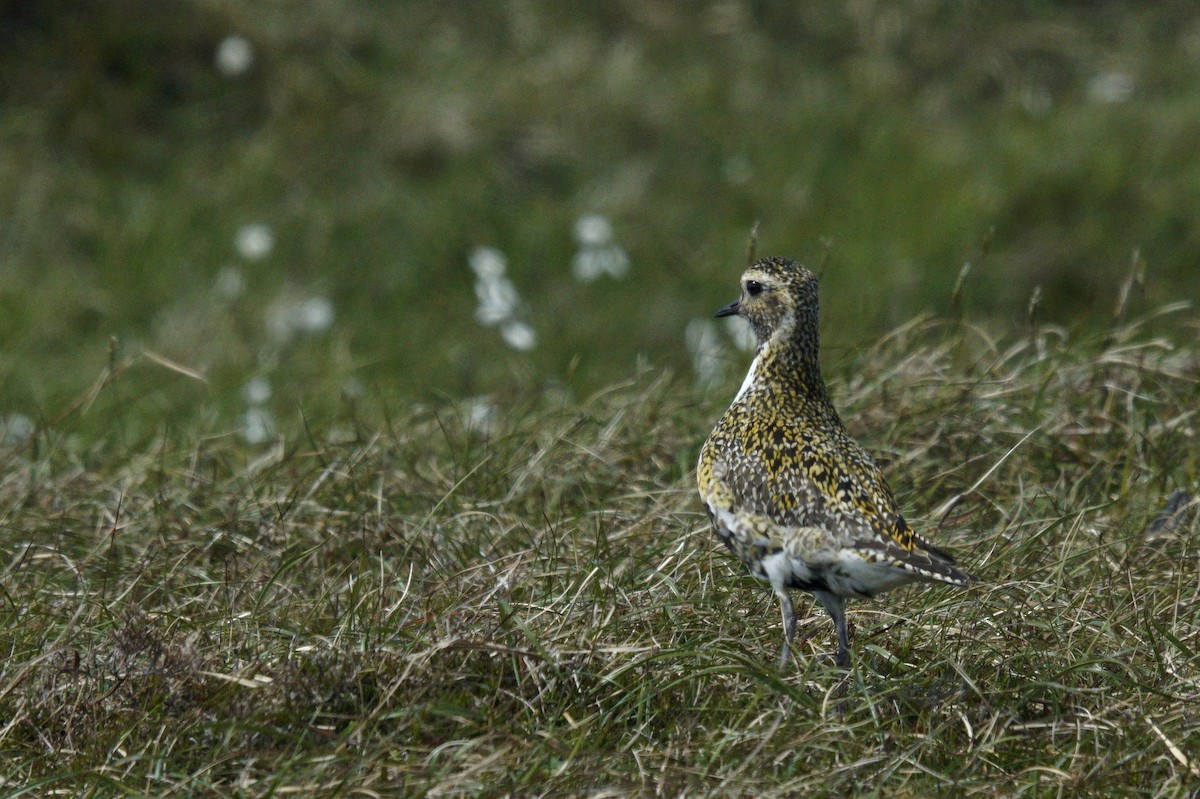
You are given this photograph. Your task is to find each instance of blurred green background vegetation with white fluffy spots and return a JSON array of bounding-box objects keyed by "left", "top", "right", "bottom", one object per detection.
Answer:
[{"left": 0, "top": 0, "right": 1200, "bottom": 438}]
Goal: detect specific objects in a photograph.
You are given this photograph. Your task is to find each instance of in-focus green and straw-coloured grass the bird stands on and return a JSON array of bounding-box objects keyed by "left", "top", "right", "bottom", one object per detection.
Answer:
[{"left": 0, "top": 297, "right": 1200, "bottom": 798}]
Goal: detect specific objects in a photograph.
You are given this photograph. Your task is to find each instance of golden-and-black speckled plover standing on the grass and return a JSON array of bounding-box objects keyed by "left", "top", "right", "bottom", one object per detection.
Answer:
[{"left": 696, "top": 257, "right": 979, "bottom": 669}]
